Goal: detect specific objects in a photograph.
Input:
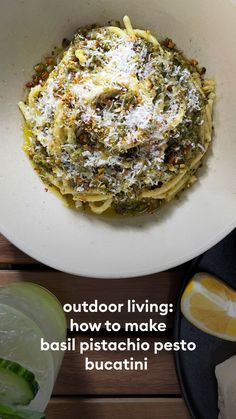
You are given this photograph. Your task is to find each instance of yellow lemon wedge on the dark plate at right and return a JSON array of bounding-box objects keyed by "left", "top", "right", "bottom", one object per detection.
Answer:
[{"left": 181, "top": 272, "right": 236, "bottom": 341}]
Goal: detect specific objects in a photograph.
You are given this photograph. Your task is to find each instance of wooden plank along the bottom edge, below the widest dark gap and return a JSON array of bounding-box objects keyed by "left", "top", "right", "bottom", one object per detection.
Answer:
[{"left": 46, "top": 398, "right": 190, "bottom": 419}]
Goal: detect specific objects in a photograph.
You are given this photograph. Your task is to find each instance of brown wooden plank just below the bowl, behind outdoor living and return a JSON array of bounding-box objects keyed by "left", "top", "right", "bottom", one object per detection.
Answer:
[{"left": 0, "top": 270, "right": 184, "bottom": 328}]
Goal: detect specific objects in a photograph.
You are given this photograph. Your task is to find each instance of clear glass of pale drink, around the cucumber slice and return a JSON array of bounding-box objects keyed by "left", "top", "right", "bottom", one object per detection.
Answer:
[{"left": 0, "top": 282, "right": 67, "bottom": 412}]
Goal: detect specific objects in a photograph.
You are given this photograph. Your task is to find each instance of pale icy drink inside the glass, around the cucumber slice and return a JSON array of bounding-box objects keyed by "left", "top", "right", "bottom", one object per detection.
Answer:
[{"left": 0, "top": 304, "right": 55, "bottom": 412}]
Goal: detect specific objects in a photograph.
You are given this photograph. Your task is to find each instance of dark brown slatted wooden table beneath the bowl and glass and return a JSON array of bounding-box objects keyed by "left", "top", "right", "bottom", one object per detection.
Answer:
[{"left": 0, "top": 235, "right": 189, "bottom": 419}]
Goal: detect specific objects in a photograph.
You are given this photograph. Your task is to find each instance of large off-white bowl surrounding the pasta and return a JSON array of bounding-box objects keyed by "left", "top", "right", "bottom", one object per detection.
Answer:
[{"left": 0, "top": 0, "right": 236, "bottom": 278}]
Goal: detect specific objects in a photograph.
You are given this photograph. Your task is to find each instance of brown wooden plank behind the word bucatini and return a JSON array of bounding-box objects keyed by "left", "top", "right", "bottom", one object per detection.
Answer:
[{"left": 54, "top": 335, "right": 180, "bottom": 396}]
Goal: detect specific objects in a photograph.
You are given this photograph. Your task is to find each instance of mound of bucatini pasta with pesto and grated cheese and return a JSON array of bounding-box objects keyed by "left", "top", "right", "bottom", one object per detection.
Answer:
[{"left": 19, "top": 16, "right": 215, "bottom": 214}]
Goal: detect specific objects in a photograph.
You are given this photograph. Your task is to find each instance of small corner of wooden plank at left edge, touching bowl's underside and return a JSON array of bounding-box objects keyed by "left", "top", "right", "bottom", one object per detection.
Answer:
[{"left": 0, "top": 234, "right": 36, "bottom": 264}]
